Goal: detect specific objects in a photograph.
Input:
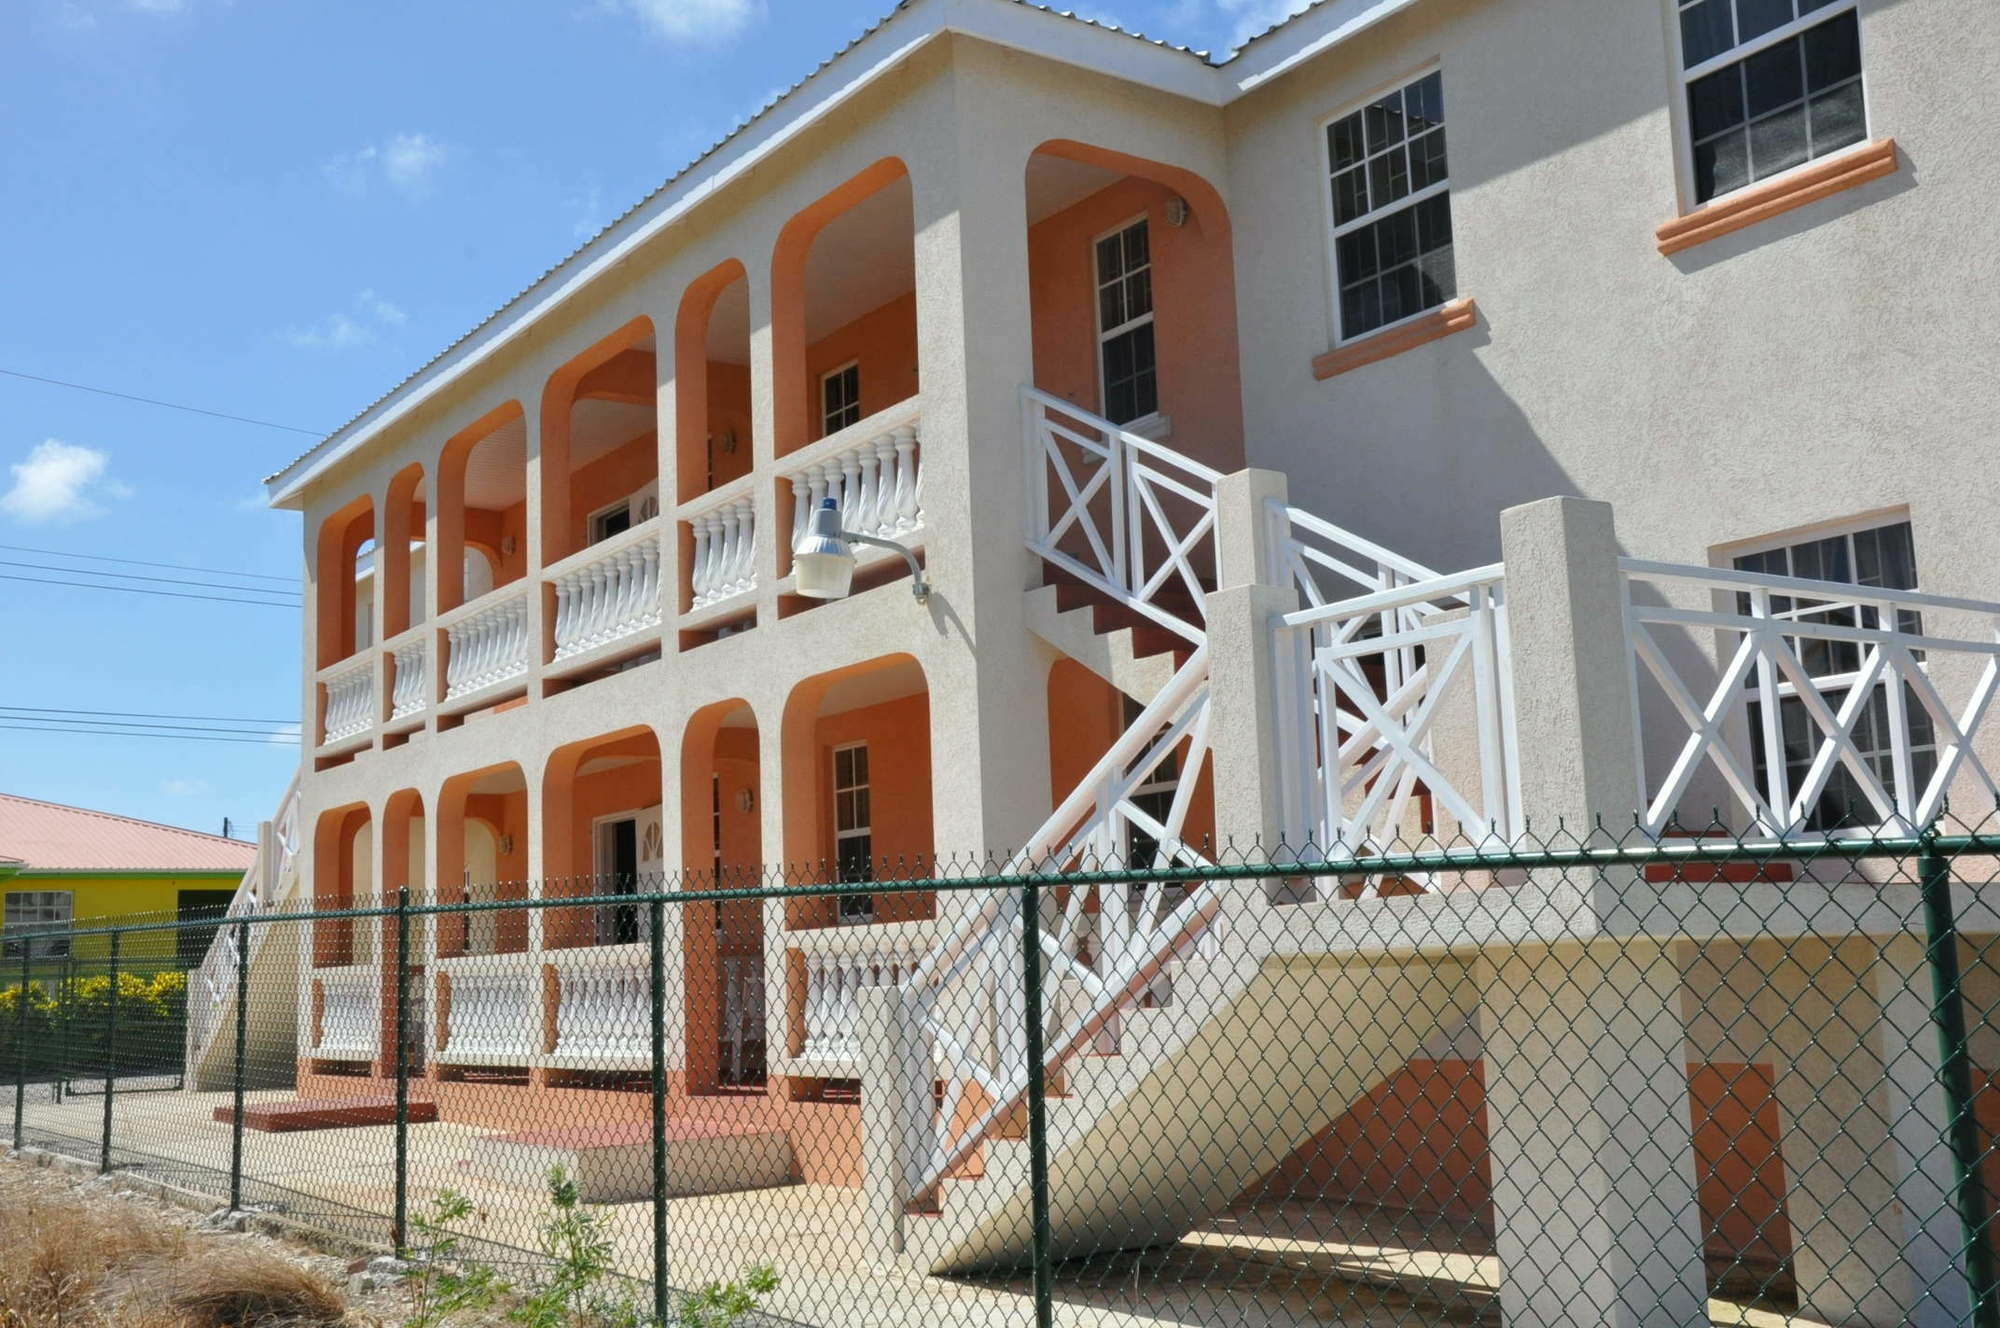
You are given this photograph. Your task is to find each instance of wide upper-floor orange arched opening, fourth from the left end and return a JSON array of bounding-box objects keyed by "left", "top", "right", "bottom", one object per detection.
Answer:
[{"left": 540, "top": 318, "right": 660, "bottom": 564}]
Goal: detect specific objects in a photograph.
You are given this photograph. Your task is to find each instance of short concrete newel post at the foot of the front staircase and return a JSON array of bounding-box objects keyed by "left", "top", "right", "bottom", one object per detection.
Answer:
[{"left": 856, "top": 986, "right": 930, "bottom": 1258}]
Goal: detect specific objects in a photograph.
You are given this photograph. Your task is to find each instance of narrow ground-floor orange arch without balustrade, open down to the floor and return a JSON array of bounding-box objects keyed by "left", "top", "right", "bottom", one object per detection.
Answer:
[{"left": 680, "top": 700, "right": 766, "bottom": 1094}]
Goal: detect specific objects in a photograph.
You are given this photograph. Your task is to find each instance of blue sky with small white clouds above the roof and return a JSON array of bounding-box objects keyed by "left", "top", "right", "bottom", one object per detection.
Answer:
[{"left": 0, "top": 0, "right": 1294, "bottom": 830}]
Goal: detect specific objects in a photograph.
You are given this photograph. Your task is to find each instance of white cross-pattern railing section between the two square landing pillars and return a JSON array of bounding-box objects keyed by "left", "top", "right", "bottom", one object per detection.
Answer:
[{"left": 1274, "top": 564, "right": 1520, "bottom": 860}]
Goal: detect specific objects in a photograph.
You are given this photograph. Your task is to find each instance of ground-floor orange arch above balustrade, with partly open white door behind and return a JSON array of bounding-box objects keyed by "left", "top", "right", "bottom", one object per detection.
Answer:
[{"left": 542, "top": 726, "right": 666, "bottom": 950}]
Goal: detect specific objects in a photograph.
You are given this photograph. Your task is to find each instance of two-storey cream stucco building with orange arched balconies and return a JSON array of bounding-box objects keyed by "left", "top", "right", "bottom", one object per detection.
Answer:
[{"left": 195, "top": 0, "right": 2000, "bottom": 1322}]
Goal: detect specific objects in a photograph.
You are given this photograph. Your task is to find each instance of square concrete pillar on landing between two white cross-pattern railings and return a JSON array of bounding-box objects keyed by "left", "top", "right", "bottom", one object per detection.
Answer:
[{"left": 1500, "top": 498, "right": 1640, "bottom": 844}]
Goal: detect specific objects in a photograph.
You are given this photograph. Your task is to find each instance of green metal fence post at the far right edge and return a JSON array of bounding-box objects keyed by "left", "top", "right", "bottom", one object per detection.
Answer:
[{"left": 1916, "top": 844, "right": 2000, "bottom": 1328}]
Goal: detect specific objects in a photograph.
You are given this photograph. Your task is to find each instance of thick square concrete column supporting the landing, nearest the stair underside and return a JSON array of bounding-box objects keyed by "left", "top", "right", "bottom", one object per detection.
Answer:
[{"left": 1478, "top": 942, "right": 1708, "bottom": 1328}]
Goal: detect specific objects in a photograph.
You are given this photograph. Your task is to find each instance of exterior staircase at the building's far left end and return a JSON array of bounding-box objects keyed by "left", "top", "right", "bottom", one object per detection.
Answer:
[{"left": 186, "top": 774, "right": 300, "bottom": 1092}]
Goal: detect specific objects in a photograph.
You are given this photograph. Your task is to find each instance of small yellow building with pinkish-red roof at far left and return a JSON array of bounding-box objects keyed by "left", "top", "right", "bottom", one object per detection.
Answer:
[{"left": 0, "top": 794, "right": 256, "bottom": 968}]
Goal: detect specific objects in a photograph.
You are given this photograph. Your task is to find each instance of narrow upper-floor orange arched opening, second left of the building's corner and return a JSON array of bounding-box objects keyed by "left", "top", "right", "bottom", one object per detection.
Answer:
[{"left": 674, "top": 258, "right": 754, "bottom": 502}]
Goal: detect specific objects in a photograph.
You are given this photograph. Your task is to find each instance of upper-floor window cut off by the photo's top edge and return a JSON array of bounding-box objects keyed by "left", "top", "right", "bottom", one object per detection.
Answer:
[{"left": 1680, "top": 0, "right": 1868, "bottom": 202}]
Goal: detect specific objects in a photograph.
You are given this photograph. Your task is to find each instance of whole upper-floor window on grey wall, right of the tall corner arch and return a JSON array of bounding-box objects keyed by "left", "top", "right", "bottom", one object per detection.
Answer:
[{"left": 1326, "top": 70, "right": 1458, "bottom": 340}]
